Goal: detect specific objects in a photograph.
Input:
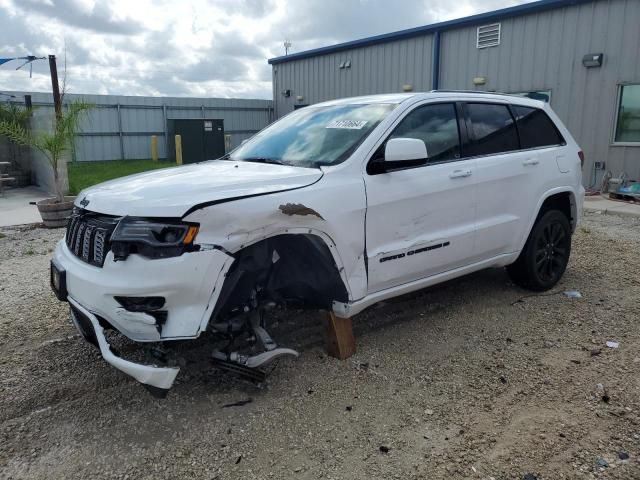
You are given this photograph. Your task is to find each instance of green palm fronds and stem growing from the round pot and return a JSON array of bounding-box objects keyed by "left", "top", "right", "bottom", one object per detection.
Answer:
[{"left": 0, "top": 100, "right": 92, "bottom": 202}]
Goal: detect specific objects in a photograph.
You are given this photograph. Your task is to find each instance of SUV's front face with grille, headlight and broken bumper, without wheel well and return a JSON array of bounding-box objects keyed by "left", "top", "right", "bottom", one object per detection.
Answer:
[{"left": 51, "top": 208, "right": 233, "bottom": 396}]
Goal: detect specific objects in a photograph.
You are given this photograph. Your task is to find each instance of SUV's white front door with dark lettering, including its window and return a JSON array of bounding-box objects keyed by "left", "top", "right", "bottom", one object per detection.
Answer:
[{"left": 365, "top": 103, "right": 476, "bottom": 293}]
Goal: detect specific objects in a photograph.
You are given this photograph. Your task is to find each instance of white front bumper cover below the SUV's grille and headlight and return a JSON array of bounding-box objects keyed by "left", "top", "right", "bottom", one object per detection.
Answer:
[{"left": 53, "top": 240, "right": 233, "bottom": 342}]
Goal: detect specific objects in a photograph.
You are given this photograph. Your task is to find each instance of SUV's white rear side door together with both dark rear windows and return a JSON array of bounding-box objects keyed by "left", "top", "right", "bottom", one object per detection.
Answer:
[{"left": 465, "top": 102, "right": 562, "bottom": 260}]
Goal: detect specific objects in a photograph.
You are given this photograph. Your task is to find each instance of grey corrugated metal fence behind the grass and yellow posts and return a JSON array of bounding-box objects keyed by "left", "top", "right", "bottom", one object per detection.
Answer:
[{"left": 7, "top": 92, "right": 273, "bottom": 161}]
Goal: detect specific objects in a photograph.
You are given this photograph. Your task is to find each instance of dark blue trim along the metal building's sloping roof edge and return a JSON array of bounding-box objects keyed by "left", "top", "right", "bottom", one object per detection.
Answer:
[{"left": 268, "top": 0, "right": 594, "bottom": 65}]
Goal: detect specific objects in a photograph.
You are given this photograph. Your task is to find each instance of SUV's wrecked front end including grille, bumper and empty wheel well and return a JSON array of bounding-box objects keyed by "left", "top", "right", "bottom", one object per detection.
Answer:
[{"left": 52, "top": 211, "right": 348, "bottom": 397}]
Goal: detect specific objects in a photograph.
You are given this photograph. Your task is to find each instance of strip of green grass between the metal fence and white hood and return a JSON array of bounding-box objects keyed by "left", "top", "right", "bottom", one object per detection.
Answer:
[{"left": 67, "top": 160, "right": 175, "bottom": 195}]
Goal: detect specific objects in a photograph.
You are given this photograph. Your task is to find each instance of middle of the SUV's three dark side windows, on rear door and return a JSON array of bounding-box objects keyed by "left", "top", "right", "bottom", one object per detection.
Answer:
[{"left": 467, "top": 103, "right": 519, "bottom": 155}]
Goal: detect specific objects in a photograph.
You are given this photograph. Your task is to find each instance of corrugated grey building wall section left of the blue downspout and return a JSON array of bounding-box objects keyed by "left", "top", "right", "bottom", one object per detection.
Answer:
[{"left": 273, "top": 36, "right": 432, "bottom": 117}]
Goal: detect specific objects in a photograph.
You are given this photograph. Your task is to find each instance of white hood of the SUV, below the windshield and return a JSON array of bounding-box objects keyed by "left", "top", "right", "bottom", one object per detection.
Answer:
[{"left": 75, "top": 160, "right": 322, "bottom": 217}]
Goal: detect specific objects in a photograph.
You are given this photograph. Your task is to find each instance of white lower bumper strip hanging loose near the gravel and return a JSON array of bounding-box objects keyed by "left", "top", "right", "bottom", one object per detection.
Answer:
[{"left": 68, "top": 297, "right": 180, "bottom": 396}]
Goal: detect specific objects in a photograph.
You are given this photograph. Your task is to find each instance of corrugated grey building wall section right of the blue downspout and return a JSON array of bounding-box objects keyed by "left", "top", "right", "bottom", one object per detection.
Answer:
[{"left": 440, "top": 0, "right": 640, "bottom": 185}]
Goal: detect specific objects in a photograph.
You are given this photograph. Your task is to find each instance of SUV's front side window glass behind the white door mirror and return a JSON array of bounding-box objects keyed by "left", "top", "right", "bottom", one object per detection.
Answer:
[{"left": 389, "top": 103, "right": 460, "bottom": 163}]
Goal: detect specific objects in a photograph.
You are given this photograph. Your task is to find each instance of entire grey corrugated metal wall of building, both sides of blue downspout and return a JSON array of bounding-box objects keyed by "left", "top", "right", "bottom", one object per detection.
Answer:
[{"left": 273, "top": 0, "right": 640, "bottom": 185}]
